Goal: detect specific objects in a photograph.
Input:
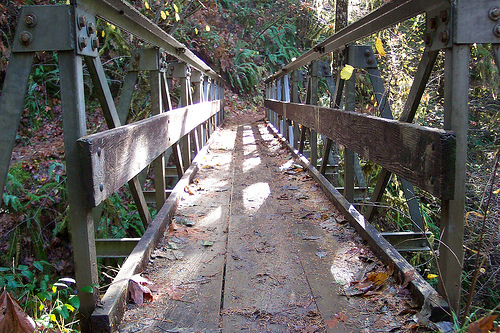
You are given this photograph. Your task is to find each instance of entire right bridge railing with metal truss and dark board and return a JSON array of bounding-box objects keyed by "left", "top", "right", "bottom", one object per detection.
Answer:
[{"left": 265, "top": 0, "right": 500, "bottom": 311}]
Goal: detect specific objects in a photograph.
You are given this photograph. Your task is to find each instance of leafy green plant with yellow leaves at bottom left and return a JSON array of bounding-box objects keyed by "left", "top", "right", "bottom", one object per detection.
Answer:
[{"left": 0, "top": 261, "right": 80, "bottom": 332}]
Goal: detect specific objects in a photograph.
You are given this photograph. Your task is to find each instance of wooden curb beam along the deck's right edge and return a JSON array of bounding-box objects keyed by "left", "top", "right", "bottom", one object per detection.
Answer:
[{"left": 268, "top": 121, "right": 449, "bottom": 315}]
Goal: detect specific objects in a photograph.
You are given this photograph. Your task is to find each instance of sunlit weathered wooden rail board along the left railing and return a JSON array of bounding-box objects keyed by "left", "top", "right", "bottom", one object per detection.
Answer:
[{"left": 78, "top": 100, "right": 220, "bottom": 207}]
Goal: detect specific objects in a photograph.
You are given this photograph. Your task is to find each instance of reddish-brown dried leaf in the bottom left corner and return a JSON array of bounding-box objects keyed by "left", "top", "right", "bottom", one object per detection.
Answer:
[{"left": 0, "top": 290, "right": 36, "bottom": 333}]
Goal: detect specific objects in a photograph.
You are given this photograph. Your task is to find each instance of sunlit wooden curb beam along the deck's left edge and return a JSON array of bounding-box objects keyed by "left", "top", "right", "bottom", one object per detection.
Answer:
[{"left": 91, "top": 141, "right": 207, "bottom": 332}]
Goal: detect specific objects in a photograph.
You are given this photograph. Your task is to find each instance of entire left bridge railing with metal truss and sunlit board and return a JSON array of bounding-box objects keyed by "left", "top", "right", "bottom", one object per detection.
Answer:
[{"left": 0, "top": 0, "right": 224, "bottom": 332}]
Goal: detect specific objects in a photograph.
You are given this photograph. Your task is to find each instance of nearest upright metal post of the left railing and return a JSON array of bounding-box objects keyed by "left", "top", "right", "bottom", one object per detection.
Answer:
[{"left": 58, "top": 51, "right": 98, "bottom": 332}]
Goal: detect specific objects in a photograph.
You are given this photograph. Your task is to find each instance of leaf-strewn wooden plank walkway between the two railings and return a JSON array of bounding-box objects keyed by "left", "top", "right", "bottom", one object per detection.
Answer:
[{"left": 120, "top": 115, "right": 411, "bottom": 332}]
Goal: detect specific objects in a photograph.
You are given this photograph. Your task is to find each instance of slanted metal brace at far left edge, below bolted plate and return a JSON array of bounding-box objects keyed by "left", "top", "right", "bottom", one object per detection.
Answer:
[{"left": 0, "top": 52, "right": 34, "bottom": 205}]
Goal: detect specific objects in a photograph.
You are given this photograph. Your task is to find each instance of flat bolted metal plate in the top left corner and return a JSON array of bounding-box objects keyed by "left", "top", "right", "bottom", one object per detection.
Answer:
[{"left": 12, "top": 5, "right": 75, "bottom": 52}]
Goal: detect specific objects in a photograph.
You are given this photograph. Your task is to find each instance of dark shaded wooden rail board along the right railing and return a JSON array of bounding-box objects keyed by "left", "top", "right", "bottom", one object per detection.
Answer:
[{"left": 264, "top": 100, "right": 456, "bottom": 199}]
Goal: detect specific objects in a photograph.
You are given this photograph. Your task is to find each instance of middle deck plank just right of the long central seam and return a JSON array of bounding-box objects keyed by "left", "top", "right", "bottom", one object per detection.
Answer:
[{"left": 221, "top": 124, "right": 317, "bottom": 332}]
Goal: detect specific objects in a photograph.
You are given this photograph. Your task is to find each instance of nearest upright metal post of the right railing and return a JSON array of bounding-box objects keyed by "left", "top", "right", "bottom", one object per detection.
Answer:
[{"left": 439, "top": 45, "right": 470, "bottom": 313}]
